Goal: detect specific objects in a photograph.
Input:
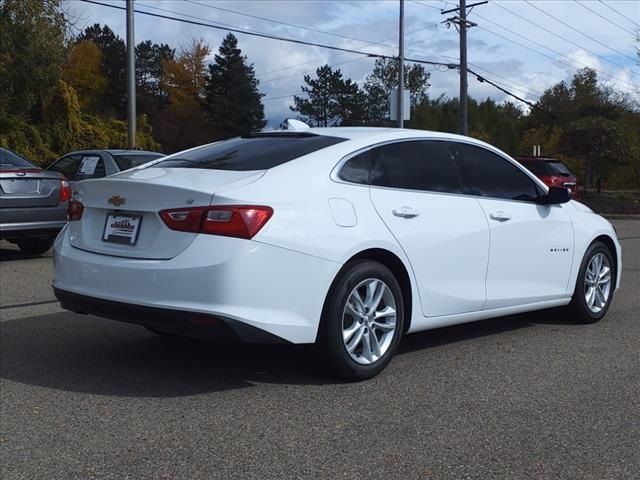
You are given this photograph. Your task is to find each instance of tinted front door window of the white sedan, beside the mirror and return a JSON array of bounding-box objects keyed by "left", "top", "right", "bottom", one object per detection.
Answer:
[{"left": 456, "top": 143, "right": 538, "bottom": 202}]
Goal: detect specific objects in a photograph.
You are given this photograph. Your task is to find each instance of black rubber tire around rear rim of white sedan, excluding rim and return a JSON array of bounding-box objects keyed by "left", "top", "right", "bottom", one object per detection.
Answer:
[{"left": 320, "top": 260, "right": 405, "bottom": 380}]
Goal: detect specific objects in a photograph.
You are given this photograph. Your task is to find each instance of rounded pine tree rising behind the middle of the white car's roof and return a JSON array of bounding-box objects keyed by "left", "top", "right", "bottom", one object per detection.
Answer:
[{"left": 290, "top": 65, "right": 366, "bottom": 127}]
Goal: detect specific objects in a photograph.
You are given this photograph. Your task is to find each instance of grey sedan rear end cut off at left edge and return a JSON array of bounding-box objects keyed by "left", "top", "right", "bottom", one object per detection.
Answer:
[{"left": 0, "top": 147, "right": 71, "bottom": 255}]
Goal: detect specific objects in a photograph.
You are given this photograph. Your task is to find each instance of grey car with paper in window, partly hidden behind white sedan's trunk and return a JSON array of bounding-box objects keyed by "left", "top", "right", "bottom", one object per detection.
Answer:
[{"left": 47, "top": 150, "right": 163, "bottom": 184}]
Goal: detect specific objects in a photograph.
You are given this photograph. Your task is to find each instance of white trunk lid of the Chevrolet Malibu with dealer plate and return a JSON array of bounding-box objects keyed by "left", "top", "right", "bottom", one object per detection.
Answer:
[{"left": 69, "top": 167, "right": 264, "bottom": 259}]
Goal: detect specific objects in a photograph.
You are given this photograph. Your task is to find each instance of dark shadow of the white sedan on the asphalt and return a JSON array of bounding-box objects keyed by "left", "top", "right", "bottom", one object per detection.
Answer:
[{"left": 0, "top": 312, "right": 576, "bottom": 398}]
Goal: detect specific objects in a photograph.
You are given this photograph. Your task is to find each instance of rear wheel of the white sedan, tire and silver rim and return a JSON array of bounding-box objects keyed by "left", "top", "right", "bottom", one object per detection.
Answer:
[{"left": 320, "top": 260, "right": 404, "bottom": 380}]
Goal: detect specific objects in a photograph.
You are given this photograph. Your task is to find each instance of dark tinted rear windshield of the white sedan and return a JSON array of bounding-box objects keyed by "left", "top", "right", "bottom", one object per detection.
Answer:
[{"left": 151, "top": 132, "right": 346, "bottom": 171}]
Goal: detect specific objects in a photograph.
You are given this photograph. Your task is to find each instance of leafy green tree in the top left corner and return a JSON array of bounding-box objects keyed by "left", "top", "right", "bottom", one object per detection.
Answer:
[{"left": 0, "top": 0, "right": 67, "bottom": 121}]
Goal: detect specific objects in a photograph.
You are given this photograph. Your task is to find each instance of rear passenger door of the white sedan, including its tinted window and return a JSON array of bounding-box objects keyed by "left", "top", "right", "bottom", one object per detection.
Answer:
[{"left": 370, "top": 140, "right": 489, "bottom": 317}]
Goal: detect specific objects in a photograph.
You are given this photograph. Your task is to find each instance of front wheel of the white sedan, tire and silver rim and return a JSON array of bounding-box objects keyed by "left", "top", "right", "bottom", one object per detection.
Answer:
[{"left": 569, "top": 242, "right": 616, "bottom": 323}]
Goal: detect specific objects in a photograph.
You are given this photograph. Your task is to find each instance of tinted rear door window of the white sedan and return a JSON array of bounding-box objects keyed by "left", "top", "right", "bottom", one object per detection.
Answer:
[{"left": 371, "top": 141, "right": 462, "bottom": 193}]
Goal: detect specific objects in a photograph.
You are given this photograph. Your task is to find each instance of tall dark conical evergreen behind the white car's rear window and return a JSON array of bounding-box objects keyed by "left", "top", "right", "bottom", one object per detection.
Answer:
[{"left": 204, "top": 33, "right": 266, "bottom": 138}]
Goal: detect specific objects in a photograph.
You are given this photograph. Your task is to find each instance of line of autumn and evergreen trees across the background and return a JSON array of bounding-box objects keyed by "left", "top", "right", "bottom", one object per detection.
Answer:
[{"left": 0, "top": 0, "right": 640, "bottom": 188}]
